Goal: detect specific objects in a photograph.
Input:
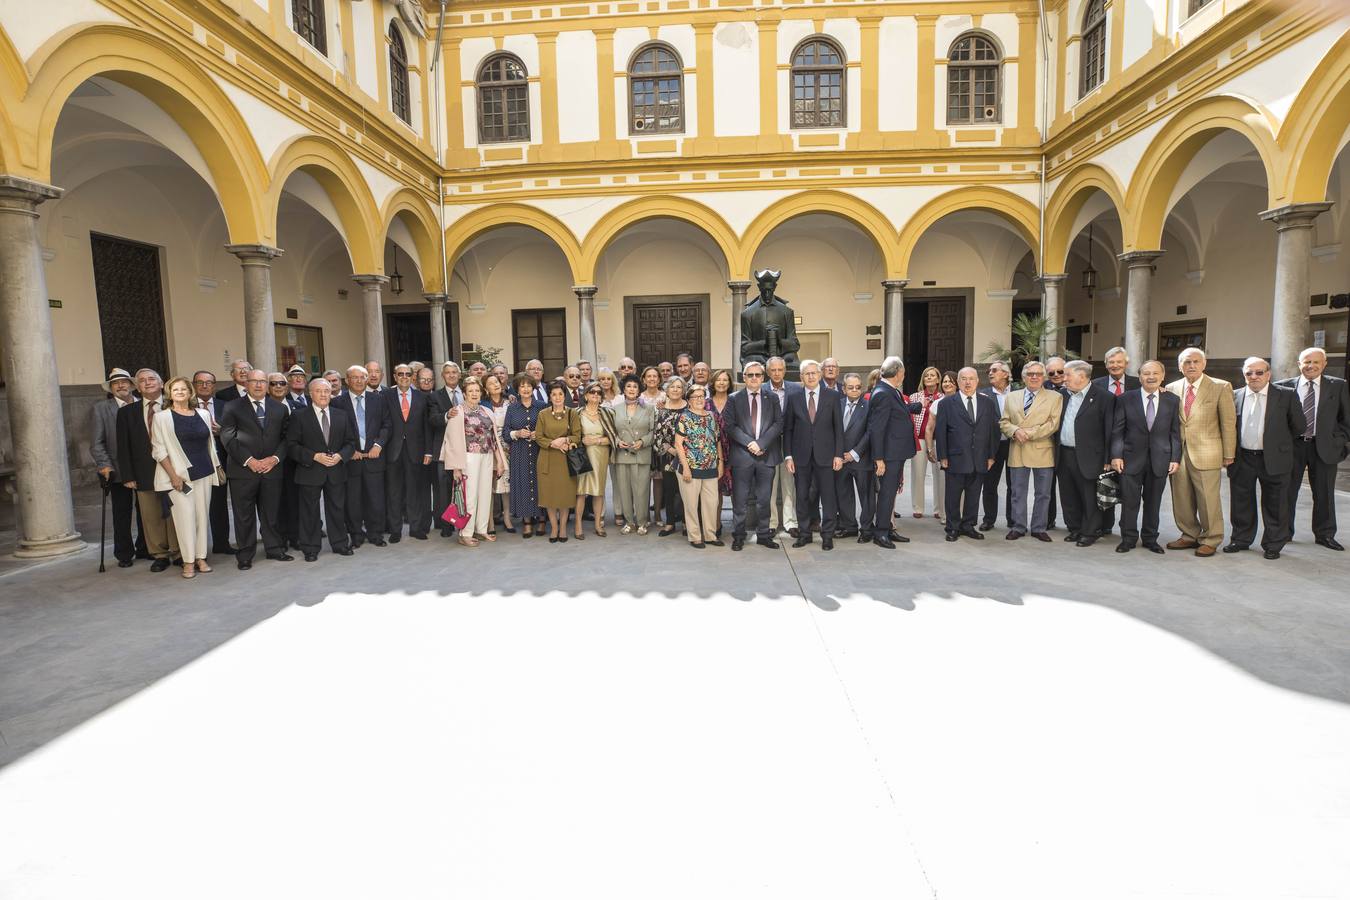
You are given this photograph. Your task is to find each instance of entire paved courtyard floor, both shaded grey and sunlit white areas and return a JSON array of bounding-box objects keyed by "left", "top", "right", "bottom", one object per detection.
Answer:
[{"left": 0, "top": 474, "right": 1350, "bottom": 900}]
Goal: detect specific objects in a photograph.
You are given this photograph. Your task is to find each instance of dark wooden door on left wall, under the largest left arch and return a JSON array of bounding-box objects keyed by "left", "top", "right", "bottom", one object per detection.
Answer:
[{"left": 89, "top": 233, "right": 170, "bottom": 379}]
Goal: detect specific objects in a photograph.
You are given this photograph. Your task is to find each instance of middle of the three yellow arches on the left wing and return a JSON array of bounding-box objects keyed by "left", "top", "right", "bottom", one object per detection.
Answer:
[{"left": 266, "top": 135, "right": 385, "bottom": 275}]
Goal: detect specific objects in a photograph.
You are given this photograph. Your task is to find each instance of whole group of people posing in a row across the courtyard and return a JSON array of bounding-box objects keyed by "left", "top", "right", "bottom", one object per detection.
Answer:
[{"left": 92, "top": 348, "right": 1350, "bottom": 578}]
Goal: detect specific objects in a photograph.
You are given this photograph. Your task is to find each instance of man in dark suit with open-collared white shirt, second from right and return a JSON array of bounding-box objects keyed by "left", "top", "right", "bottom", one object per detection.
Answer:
[{"left": 1223, "top": 356, "right": 1308, "bottom": 560}]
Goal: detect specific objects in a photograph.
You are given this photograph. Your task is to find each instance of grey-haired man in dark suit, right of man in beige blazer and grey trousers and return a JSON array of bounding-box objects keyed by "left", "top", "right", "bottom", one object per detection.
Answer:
[{"left": 1056, "top": 359, "right": 1115, "bottom": 546}]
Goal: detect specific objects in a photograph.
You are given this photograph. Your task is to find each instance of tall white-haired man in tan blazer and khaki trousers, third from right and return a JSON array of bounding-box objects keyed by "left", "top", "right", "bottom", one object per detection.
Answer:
[{"left": 1168, "top": 347, "right": 1238, "bottom": 556}]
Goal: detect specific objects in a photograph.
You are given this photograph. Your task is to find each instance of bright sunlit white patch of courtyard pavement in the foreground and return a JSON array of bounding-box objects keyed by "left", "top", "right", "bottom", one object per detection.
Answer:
[{"left": 0, "top": 592, "right": 1350, "bottom": 900}]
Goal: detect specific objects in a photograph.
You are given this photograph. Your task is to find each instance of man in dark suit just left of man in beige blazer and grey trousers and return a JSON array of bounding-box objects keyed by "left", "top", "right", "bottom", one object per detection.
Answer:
[{"left": 933, "top": 366, "right": 1000, "bottom": 541}]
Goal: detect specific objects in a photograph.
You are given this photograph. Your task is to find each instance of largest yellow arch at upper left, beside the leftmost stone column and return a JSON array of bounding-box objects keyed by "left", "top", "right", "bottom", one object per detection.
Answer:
[{"left": 25, "top": 24, "right": 265, "bottom": 243}]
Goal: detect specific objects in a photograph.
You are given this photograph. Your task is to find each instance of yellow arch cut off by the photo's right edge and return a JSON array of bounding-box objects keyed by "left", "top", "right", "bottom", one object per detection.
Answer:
[{"left": 1280, "top": 32, "right": 1350, "bottom": 204}]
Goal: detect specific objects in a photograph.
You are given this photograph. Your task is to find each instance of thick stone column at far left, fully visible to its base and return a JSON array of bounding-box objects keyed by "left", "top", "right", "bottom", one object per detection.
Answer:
[{"left": 0, "top": 175, "right": 85, "bottom": 559}]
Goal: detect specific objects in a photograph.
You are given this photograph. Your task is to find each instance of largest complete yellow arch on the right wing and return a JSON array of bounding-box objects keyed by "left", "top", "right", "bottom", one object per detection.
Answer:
[{"left": 1122, "top": 96, "right": 1280, "bottom": 252}]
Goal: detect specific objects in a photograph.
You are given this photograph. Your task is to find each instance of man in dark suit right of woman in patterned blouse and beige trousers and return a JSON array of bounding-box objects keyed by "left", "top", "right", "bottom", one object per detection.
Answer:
[{"left": 722, "top": 362, "right": 783, "bottom": 551}]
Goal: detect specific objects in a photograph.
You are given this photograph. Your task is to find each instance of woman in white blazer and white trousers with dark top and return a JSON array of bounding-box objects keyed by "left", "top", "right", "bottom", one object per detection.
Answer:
[{"left": 150, "top": 376, "right": 220, "bottom": 578}]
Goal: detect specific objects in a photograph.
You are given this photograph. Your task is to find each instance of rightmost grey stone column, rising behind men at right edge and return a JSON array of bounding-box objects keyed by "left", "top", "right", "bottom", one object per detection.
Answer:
[{"left": 1261, "top": 202, "right": 1331, "bottom": 378}]
